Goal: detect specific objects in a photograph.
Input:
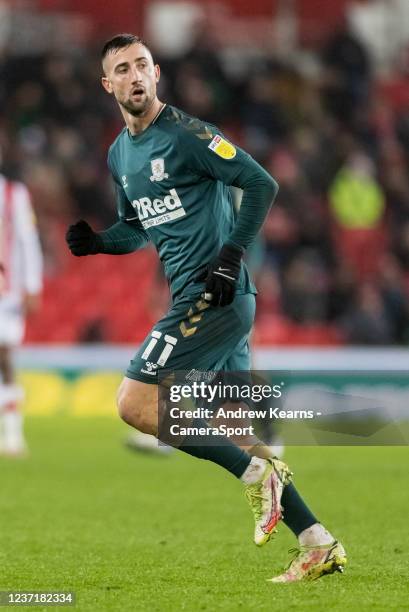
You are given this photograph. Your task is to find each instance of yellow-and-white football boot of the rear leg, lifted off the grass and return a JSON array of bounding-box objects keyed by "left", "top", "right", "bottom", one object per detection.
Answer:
[{"left": 245, "top": 458, "right": 292, "bottom": 546}]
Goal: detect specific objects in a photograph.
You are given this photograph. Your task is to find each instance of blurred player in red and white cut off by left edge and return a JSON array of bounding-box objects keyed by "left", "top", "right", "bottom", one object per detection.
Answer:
[{"left": 0, "top": 175, "right": 42, "bottom": 456}]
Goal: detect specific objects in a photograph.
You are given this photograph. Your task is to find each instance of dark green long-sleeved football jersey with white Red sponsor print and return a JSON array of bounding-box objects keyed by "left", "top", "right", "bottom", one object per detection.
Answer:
[{"left": 100, "top": 105, "right": 277, "bottom": 298}]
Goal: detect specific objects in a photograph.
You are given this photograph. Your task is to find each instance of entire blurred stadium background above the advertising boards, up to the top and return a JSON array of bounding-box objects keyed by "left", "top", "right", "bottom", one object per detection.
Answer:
[{"left": 0, "top": 0, "right": 409, "bottom": 416}]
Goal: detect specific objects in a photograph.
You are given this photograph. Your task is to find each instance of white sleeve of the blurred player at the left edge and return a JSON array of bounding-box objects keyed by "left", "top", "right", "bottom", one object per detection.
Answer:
[{"left": 15, "top": 183, "right": 43, "bottom": 295}]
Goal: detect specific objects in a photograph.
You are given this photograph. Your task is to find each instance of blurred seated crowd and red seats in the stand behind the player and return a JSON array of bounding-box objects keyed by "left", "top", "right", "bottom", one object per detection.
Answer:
[{"left": 0, "top": 0, "right": 409, "bottom": 344}]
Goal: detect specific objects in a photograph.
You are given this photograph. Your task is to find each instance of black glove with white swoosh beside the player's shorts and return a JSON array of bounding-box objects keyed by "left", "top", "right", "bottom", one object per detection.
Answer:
[{"left": 196, "top": 244, "right": 243, "bottom": 306}]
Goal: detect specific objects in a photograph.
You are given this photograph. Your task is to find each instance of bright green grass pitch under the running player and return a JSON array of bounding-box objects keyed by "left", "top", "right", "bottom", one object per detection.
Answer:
[{"left": 0, "top": 417, "right": 409, "bottom": 612}]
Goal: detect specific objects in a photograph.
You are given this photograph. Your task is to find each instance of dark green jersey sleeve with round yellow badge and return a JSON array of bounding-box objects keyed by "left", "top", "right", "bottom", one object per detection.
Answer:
[{"left": 179, "top": 119, "right": 278, "bottom": 250}]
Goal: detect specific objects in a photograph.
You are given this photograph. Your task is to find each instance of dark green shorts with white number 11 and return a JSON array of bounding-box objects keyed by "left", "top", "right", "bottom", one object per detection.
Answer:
[{"left": 126, "top": 293, "right": 256, "bottom": 384}]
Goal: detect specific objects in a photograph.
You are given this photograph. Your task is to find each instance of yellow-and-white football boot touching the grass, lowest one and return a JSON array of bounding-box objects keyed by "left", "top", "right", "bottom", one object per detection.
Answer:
[{"left": 269, "top": 541, "right": 347, "bottom": 583}]
